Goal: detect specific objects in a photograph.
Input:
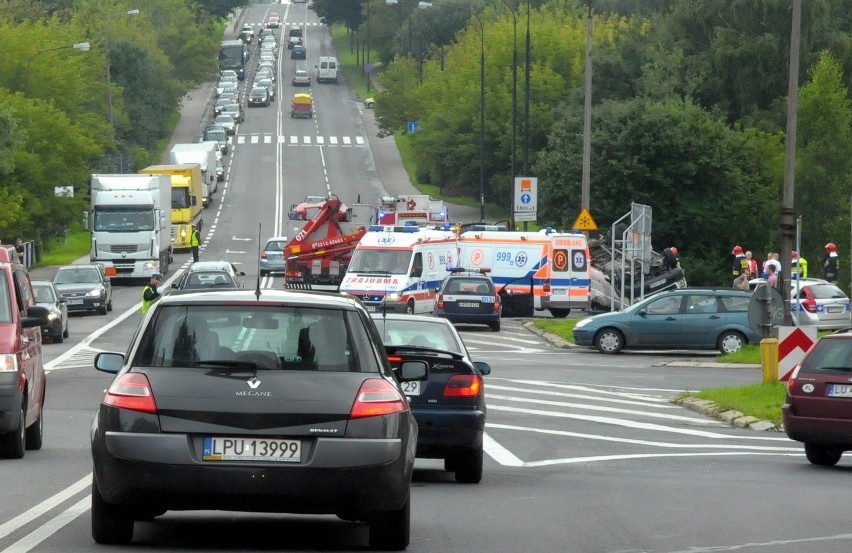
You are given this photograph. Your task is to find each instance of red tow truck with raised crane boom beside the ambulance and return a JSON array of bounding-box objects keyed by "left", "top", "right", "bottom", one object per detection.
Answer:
[{"left": 284, "top": 194, "right": 376, "bottom": 292}]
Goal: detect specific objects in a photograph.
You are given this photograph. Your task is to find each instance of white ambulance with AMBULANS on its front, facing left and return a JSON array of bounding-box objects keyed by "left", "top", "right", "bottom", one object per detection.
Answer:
[{"left": 340, "top": 225, "right": 458, "bottom": 314}]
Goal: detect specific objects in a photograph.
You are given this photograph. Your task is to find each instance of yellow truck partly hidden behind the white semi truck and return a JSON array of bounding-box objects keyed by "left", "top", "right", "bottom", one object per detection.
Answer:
[{"left": 139, "top": 163, "right": 204, "bottom": 250}]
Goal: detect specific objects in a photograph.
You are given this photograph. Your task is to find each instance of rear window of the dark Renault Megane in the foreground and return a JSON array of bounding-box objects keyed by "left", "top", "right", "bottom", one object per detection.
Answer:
[{"left": 133, "top": 304, "right": 378, "bottom": 372}]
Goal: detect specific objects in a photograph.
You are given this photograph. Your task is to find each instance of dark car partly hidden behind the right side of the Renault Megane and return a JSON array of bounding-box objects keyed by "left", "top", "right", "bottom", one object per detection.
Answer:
[{"left": 372, "top": 313, "right": 491, "bottom": 484}]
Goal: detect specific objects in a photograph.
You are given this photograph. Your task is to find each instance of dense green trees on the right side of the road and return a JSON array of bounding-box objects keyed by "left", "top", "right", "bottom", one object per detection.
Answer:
[{"left": 313, "top": 0, "right": 852, "bottom": 288}]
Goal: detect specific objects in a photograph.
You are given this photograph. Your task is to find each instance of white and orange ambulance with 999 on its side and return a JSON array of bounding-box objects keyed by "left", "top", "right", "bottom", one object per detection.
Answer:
[{"left": 458, "top": 226, "right": 591, "bottom": 318}]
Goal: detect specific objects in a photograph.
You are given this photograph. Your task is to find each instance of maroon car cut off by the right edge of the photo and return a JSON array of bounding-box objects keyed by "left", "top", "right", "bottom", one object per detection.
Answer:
[{"left": 781, "top": 329, "right": 852, "bottom": 467}]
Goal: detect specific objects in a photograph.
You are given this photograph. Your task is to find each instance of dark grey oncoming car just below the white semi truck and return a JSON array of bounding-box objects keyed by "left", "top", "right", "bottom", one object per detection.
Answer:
[{"left": 53, "top": 263, "right": 112, "bottom": 315}]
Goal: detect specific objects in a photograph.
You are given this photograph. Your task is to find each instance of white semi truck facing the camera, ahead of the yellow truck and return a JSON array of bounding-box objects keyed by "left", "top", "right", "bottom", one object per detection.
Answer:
[{"left": 83, "top": 174, "right": 172, "bottom": 279}]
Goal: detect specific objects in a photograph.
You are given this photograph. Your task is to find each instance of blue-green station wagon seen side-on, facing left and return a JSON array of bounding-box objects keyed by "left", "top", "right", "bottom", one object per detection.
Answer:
[{"left": 574, "top": 288, "right": 760, "bottom": 353}]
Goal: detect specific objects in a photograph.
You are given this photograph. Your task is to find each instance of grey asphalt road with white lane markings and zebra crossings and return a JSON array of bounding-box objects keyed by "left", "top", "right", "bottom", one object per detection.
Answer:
[{"left": 8, "top": 4, "right": 852, "bottom": 553}]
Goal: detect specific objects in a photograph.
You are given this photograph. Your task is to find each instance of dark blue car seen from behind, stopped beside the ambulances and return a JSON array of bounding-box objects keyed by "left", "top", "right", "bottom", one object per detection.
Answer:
[{"left": 435, "top": 267, "right": 503, "bottom": 332}]
